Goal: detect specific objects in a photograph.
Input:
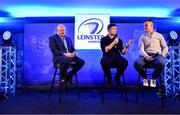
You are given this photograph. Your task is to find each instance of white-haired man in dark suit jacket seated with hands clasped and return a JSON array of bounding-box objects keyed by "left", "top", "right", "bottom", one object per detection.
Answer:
[{"left": 49, "top": 24, "right": 85, "bottom": 84}]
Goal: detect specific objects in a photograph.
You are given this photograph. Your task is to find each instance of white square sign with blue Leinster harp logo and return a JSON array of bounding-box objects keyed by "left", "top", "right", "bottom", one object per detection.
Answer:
[{"left": 74, "top": 15, "right": 109, "bottom": 49}]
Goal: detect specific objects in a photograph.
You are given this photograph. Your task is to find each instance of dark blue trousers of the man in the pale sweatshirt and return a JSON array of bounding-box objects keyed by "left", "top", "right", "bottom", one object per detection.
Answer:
[{"left": 134, "top": 55, "right": 165, "bottom": 79}]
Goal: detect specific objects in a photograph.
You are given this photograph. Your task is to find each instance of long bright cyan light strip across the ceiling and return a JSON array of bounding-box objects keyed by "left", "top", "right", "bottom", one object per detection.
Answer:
[{"left": 5, "top": 5, "right": 170, "bottom": 17}]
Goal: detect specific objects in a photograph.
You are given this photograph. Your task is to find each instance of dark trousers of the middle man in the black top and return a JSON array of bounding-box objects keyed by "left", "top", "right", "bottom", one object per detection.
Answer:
[{"left": 101, "top": 55, "right": 128, "bottom": 81}]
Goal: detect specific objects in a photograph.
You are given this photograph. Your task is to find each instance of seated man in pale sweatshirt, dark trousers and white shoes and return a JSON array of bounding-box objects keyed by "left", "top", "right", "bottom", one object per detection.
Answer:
[{"left": 134, "top": 19, "right": 168, "bottom": 87}]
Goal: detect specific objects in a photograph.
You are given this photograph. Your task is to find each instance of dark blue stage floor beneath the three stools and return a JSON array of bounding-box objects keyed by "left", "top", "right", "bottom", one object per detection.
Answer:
[{"left": 0, "top": 90, "right": 180, "bottom": 114}]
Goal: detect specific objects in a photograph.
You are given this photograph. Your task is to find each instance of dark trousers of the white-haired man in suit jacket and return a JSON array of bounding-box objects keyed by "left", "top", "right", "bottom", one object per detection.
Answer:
[{"left": 56, "top": 56, "right": 85, "bottom": 81}]
